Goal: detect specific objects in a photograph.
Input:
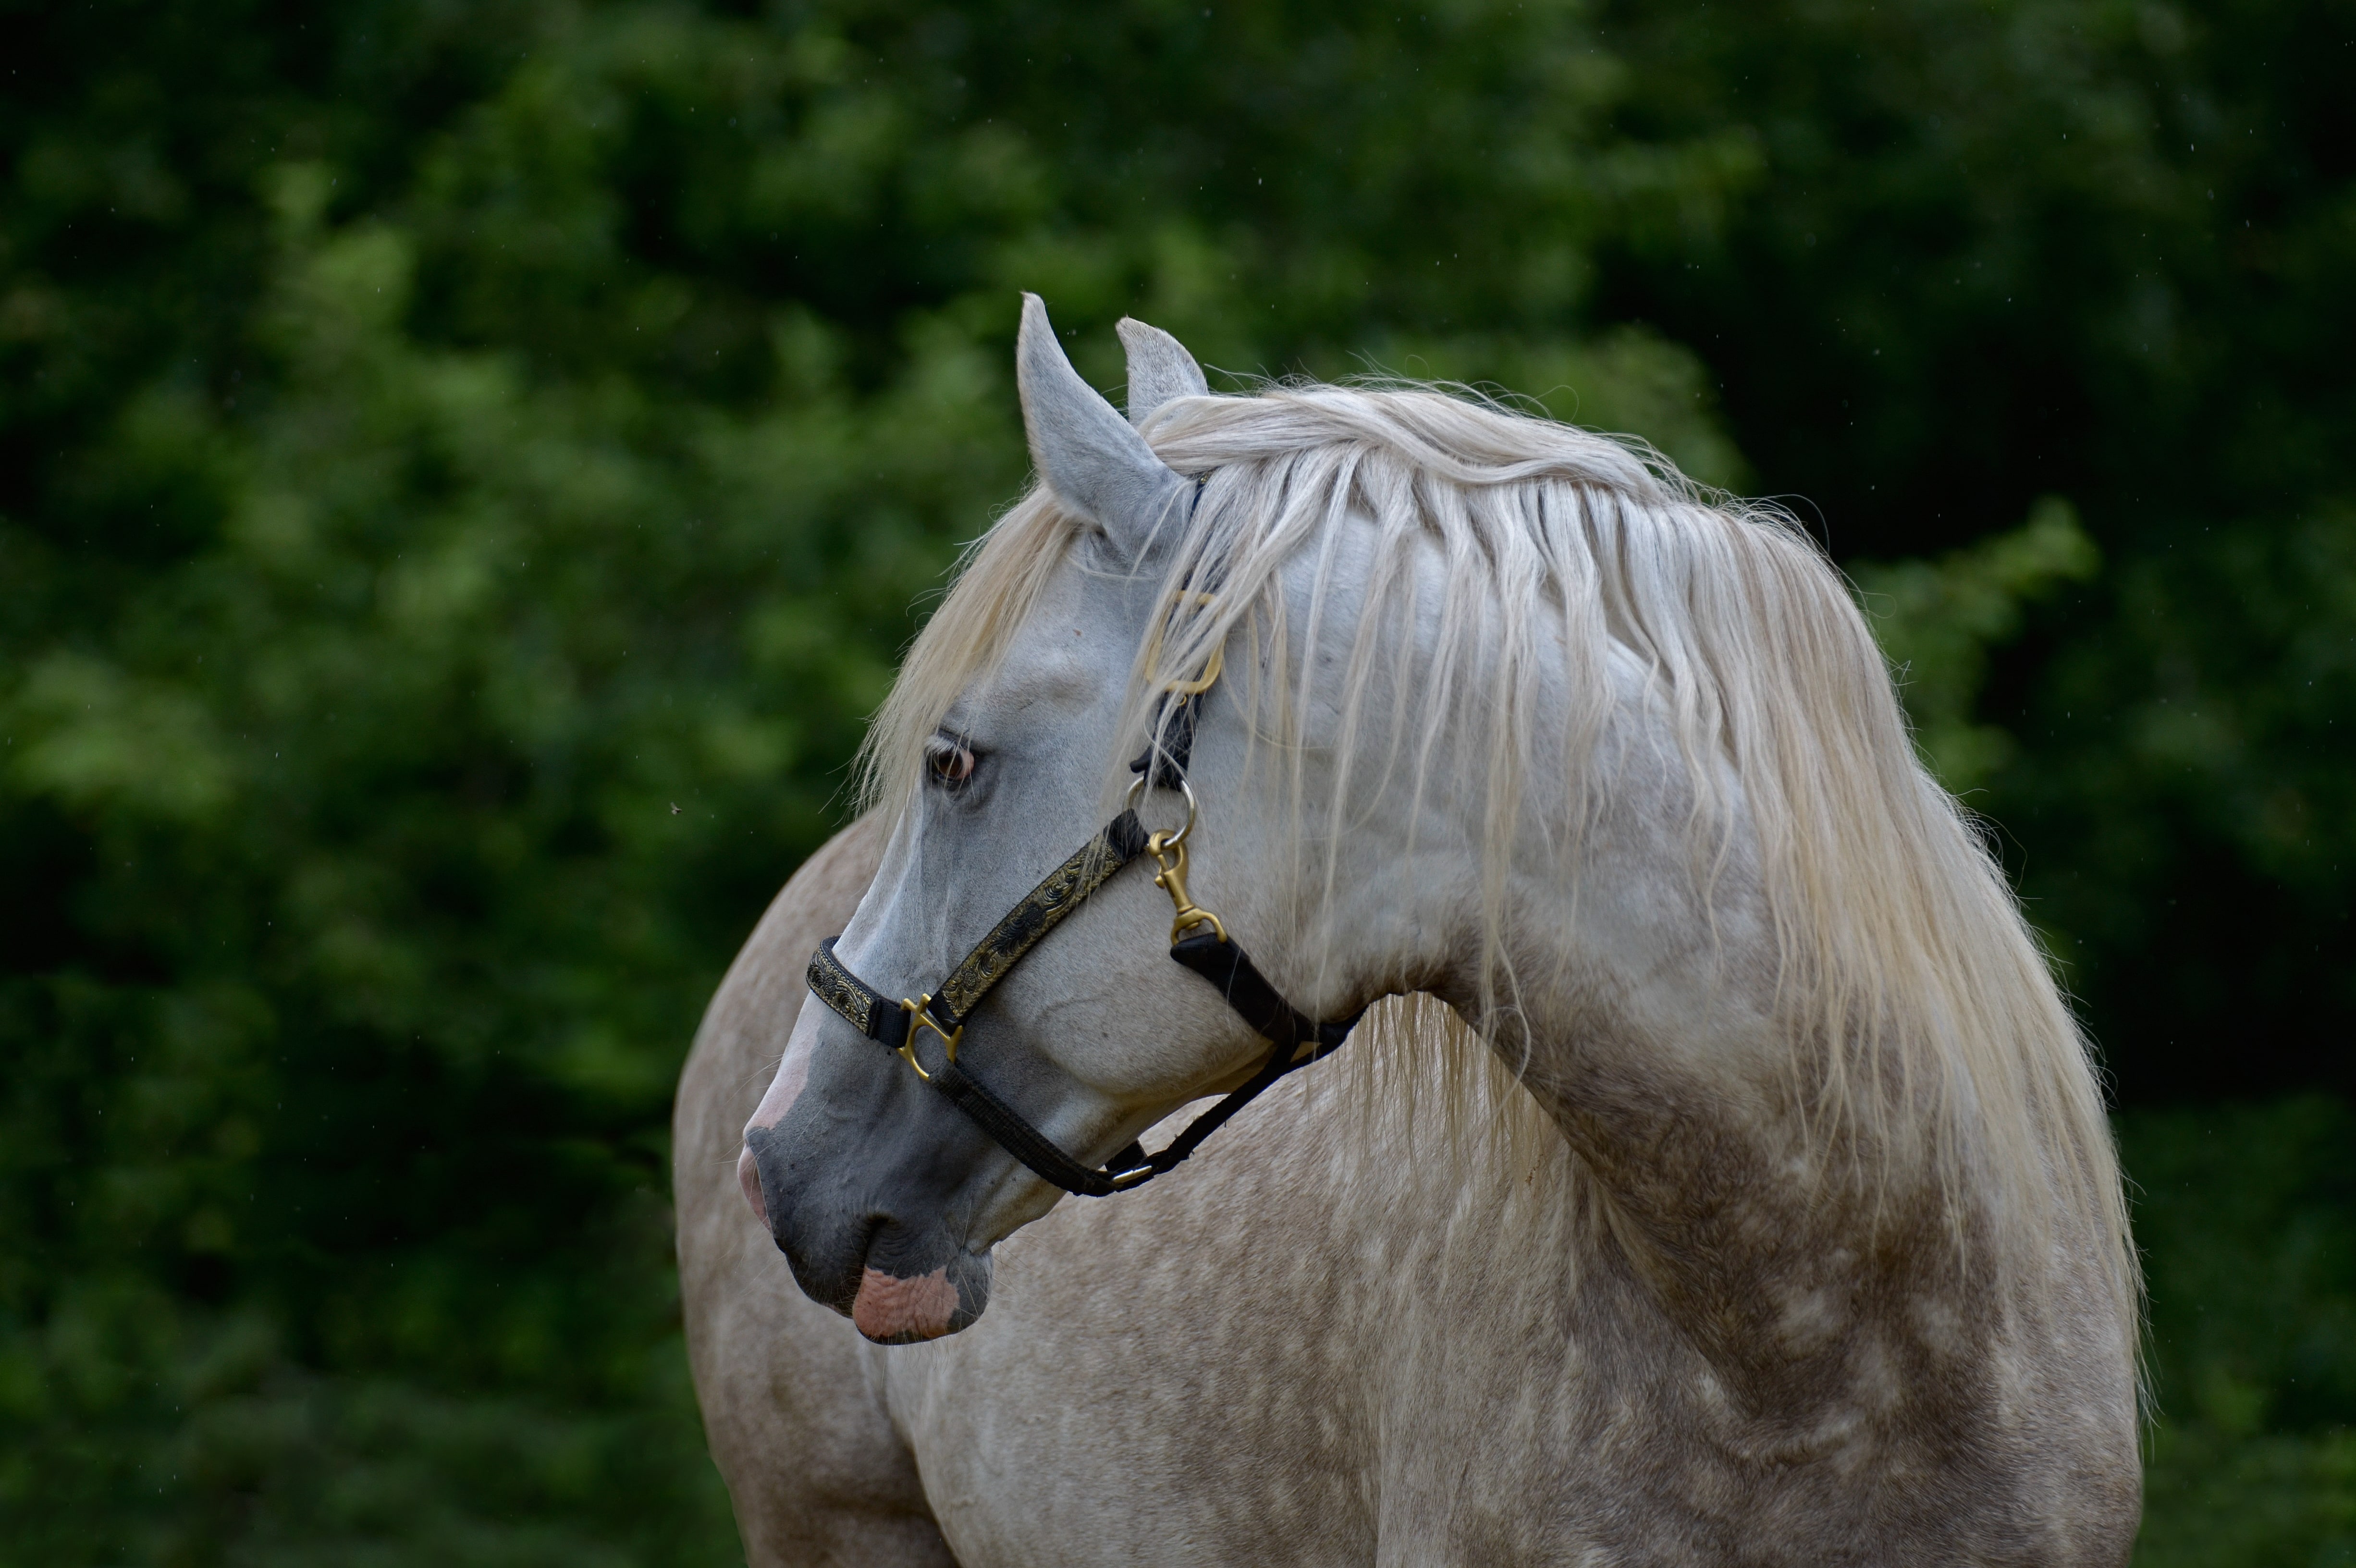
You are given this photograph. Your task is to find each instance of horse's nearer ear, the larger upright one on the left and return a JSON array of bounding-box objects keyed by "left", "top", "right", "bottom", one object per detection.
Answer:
[{"left": 1016, "top": 294, "right": 1188, "bottom": 560}]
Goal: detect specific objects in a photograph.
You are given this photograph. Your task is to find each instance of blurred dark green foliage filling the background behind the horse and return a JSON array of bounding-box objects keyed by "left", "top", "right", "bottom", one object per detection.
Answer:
[{"left": 0, "top": 0, "right": 2356, "bottom": 1566}]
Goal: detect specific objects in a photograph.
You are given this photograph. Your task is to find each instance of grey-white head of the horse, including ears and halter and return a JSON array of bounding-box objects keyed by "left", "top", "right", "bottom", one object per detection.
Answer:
[{"left": 740, "top": 297, "right": 1395, "bottom": 1342}]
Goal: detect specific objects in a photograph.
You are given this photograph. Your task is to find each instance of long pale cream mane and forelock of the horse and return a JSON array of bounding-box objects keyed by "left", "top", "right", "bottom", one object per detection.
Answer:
[{"left": 865, "top": 384, "right": 2139, "bottom": 1342}]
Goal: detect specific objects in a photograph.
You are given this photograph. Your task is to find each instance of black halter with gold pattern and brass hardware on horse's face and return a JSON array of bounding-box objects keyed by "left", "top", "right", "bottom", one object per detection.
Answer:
[{"left": 808, "top": 664, "right": 1364, "bottom": 1199}]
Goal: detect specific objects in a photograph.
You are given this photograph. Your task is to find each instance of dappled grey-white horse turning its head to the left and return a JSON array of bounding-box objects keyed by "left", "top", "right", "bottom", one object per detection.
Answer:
[{"left": 676, "top": 299, "right": 2139, "bottom": 1566}]
